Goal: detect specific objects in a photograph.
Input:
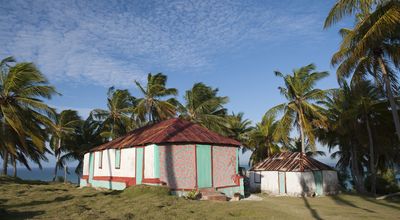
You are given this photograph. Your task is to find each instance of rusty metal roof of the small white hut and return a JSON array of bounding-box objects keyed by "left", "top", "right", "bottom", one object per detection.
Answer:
[{"left": 251, "top": 152, "right": 333, "bottom": 172}]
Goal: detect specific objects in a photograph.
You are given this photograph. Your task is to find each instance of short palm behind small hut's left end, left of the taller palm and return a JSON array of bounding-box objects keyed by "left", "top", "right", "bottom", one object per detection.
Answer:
[{"left": 248, "top": 115, "right": 280, "bottom": 164}]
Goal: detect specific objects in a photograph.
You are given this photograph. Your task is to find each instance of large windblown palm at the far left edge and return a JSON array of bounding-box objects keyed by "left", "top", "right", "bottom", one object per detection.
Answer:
[{"left": 0, "top": 57, "right": 57, "bottom": 174}]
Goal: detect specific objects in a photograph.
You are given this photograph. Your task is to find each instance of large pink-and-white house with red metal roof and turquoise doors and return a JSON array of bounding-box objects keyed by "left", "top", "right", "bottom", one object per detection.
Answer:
[{"left": 81, "top": 118, "right": 244, "bottom": 197}]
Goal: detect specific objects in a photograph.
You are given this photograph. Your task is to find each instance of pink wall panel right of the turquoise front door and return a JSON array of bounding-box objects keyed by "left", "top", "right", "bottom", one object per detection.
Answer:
[{"left": 213, "top": 146, "right": 237, "bottom": 187}]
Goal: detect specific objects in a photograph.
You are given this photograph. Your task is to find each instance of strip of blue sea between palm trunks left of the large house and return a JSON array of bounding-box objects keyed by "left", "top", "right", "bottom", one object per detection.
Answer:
[{"left": 8, "top": 167, "right": 78, "bottom": 184}]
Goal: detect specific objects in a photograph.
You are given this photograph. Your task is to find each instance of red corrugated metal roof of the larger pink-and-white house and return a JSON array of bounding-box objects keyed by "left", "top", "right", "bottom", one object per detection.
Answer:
[{"left": 92, "top": 118, "right": 241, "bottom": 151}]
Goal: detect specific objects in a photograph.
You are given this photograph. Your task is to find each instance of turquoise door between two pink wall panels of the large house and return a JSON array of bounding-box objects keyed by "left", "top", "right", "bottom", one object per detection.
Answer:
[{"left": 196, "top": 145, "right": 212, "bottom": 188}]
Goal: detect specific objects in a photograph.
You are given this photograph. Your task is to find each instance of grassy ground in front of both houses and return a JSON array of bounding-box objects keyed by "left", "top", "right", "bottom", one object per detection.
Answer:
[{"left": 0, "top": 177, "right": 400, "bottom": 220}]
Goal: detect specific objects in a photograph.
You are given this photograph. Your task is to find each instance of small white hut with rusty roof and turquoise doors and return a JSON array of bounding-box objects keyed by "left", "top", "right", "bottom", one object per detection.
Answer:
[{"left": 249, "top": 152, "right": 339, "bottom": 196}]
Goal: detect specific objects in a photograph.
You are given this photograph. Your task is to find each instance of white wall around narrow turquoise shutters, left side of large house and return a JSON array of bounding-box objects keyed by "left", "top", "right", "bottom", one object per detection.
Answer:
[{"left": 94, "top": 148, "right": 136, "bottom": 177}]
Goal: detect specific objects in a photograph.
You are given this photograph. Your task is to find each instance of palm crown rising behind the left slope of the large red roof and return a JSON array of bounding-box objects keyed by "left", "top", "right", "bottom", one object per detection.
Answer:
[{"left": 91, "top": 87, "right": 136, "bottom": 139}]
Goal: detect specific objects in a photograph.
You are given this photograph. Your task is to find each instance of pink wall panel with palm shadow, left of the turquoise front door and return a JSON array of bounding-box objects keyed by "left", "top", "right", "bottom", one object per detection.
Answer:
[{"left": 159, "top": 145, "right": 196, "bottom": 189}]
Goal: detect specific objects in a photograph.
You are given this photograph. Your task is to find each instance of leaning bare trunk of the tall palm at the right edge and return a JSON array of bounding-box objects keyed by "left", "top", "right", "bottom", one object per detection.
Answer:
[{"left": 378, "top": 57, "right": 400, "bottom": 140}]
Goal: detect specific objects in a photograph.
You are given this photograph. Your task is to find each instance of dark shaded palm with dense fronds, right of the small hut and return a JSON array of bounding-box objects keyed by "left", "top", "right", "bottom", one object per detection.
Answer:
[{"left": 320, "top": 81, "right": 393, "bottom": 194}]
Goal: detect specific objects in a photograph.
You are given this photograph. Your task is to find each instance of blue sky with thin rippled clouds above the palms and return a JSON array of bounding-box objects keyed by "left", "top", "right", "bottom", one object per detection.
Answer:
[{"left": 0, "top": 0, "right": 352, "bottom": 168}]
